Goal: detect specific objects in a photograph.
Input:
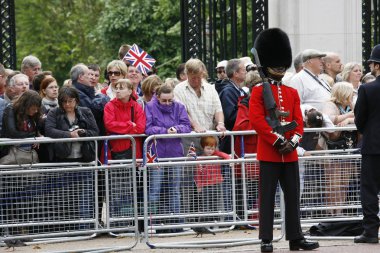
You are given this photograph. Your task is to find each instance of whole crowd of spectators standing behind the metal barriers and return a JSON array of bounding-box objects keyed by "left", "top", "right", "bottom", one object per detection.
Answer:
[{"left": 0, "top": 45, "right": 374, "bottom": 233}]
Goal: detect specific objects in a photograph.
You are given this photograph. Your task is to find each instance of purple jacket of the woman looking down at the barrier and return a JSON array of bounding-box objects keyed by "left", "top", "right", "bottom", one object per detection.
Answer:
[{"left": 145, "top": 97, "right": 191, "bottom": 159}]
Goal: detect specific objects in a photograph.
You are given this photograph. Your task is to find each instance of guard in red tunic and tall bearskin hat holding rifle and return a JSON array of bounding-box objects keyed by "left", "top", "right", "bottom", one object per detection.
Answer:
[{"left": 249, "top": 28, "right": 319, "bottom": 252}]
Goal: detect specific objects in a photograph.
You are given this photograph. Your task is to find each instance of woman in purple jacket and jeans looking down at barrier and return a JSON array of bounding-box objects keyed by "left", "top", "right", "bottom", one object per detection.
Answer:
[{"left": 145, "top": 85, "right": 191, "bottom": 232}]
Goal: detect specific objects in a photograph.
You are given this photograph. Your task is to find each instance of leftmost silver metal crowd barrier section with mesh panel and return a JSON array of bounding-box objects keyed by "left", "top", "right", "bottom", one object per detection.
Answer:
[{"left": 0, "top": 135, "right": 138, "bottom": 251}]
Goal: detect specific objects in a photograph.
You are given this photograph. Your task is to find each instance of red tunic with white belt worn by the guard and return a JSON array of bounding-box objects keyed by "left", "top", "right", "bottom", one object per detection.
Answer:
[{"left": 249, "top": 84, "right": 303, "bottom": 162}]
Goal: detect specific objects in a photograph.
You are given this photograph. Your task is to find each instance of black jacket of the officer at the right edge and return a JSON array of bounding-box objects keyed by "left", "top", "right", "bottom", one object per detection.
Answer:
[{"left": 354, "top": 76, "right": 380, "bottom": 155}]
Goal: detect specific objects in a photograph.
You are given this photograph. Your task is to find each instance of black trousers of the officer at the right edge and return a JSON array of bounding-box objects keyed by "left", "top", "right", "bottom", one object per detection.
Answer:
[{"left": 360, "top": 155, "right": 380, "bottom": 237}]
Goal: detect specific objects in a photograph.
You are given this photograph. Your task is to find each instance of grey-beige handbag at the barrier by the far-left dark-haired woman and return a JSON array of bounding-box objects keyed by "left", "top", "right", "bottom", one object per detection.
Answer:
[{"left": 0, "top": 146, "right": 39, "bottom": 165}]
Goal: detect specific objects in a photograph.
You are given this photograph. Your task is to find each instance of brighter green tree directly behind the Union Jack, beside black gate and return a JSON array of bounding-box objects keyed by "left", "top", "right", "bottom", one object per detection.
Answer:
[{"left": 96, "top": 0, "right": 181, "bottom": 77}]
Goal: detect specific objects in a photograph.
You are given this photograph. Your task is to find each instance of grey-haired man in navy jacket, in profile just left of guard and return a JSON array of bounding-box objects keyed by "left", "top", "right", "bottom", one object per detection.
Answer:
[{"left": 219, "top": 59, "right": 247, "bottom": 154}]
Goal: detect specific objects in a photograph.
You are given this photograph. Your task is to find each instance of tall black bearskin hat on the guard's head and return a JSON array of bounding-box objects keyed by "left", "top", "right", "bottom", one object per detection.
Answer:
[{"left": 254, "top": 28, "right": 292, "bottom": 69}]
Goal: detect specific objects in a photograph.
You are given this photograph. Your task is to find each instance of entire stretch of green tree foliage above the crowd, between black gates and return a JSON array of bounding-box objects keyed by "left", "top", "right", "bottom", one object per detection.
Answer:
[{"left": 15, "top": 0, "right": 181, "bottom": 83}]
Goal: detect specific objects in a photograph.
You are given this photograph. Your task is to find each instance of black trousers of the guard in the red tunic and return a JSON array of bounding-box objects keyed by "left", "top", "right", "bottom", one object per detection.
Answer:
[{"left": 259, "top": 161, "right": 303, "bottom": 240}]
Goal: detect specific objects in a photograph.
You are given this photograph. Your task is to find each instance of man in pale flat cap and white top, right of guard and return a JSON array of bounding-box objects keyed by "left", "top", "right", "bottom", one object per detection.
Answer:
[{"left": 289, "top": 49, "right": 331, "bottom": 111}]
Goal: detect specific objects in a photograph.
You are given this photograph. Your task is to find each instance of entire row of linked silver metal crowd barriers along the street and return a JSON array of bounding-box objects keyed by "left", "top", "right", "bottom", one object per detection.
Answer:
[{"left": 0, "top": 127, "right": 378, "bottom": 251}]
